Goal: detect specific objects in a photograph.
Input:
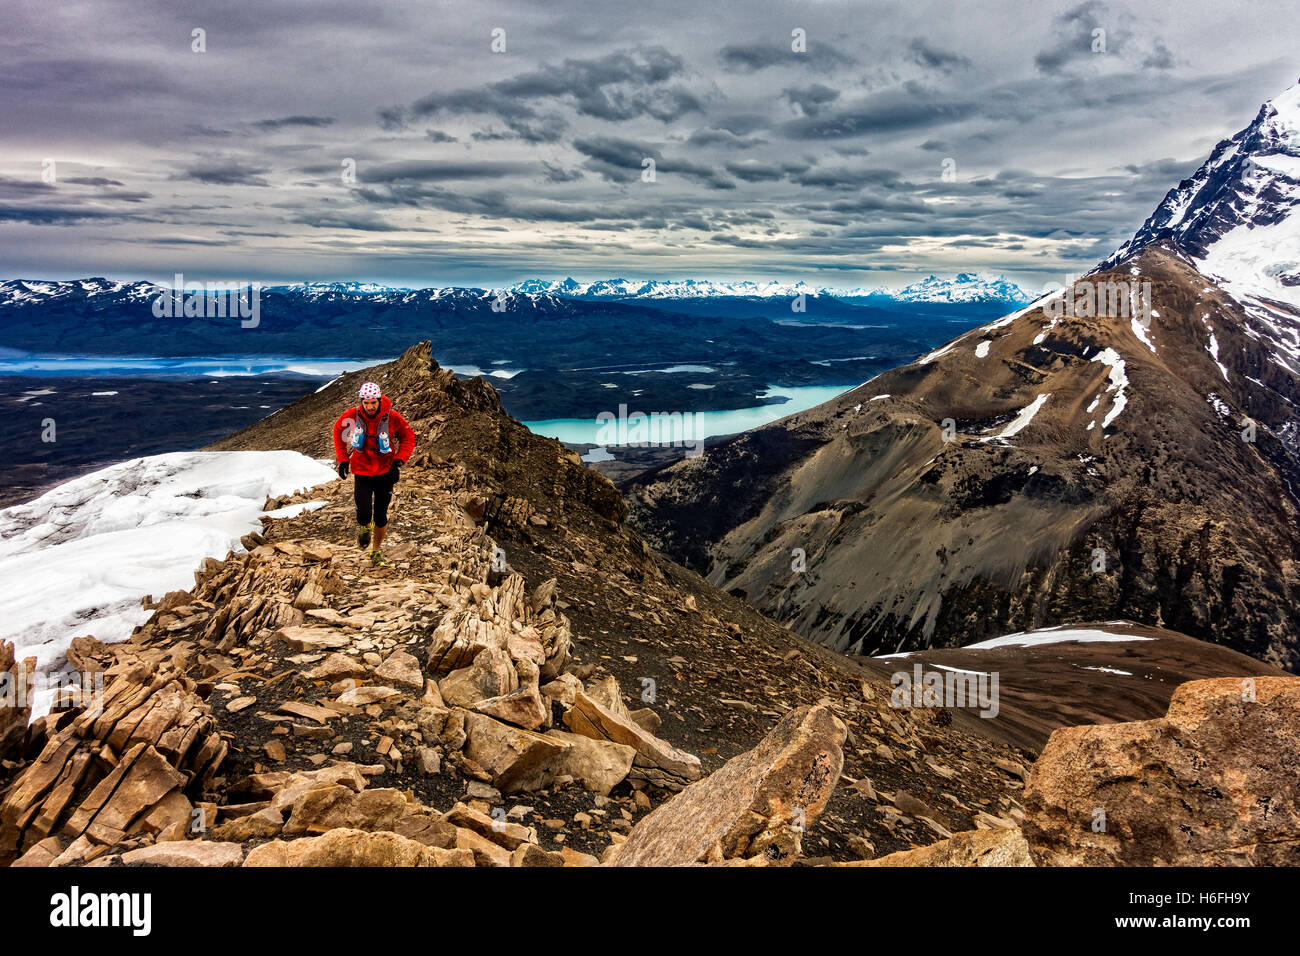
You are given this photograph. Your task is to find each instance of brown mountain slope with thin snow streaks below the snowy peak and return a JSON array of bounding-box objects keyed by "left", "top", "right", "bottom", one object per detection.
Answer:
[{"left": 627, "top": 246, "right": 1300, "bottom": 670}]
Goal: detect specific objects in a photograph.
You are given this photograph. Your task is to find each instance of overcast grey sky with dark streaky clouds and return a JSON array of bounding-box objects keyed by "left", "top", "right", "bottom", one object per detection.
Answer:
[{"left": 0, "top": 0, "right": 1300, "bottom": 289}]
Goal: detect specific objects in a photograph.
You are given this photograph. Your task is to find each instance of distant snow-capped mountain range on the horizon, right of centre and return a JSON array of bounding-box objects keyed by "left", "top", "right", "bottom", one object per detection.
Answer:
[{"left": 501, "top": 272, "right": 1031, "bottom": 303}]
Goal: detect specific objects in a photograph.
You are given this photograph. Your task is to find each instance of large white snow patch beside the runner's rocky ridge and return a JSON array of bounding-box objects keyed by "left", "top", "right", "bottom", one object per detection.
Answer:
[{"left": 0, "top": 451, "right": 335, "bottom": 715}]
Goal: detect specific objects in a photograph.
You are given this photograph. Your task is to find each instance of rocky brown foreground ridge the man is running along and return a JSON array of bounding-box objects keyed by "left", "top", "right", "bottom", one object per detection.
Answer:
[{"left": 0, "top": 343, "right": 1300, "bottom": 866}]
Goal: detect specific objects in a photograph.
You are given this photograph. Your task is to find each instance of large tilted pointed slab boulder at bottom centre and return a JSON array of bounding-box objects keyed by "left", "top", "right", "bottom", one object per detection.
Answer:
[{"left": 612, "top": 702, "right": 848, "bottom": 866}]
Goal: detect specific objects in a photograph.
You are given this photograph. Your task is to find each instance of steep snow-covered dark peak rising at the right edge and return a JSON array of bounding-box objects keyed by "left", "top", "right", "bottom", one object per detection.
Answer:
[{"left": 1101, "top": 85, "right": 1300, "bottom": 308}]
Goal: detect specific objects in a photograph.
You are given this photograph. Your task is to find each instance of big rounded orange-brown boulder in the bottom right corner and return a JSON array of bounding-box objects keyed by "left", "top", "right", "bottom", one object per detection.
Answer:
[{"left": 1022, "top": 678, "right": 1300, "bottom": 866}]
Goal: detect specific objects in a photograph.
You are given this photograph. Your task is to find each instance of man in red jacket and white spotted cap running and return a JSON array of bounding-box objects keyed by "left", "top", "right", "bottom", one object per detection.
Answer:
[{"left": 334, "top": 381, "right": 415, "bottom": 567}]
